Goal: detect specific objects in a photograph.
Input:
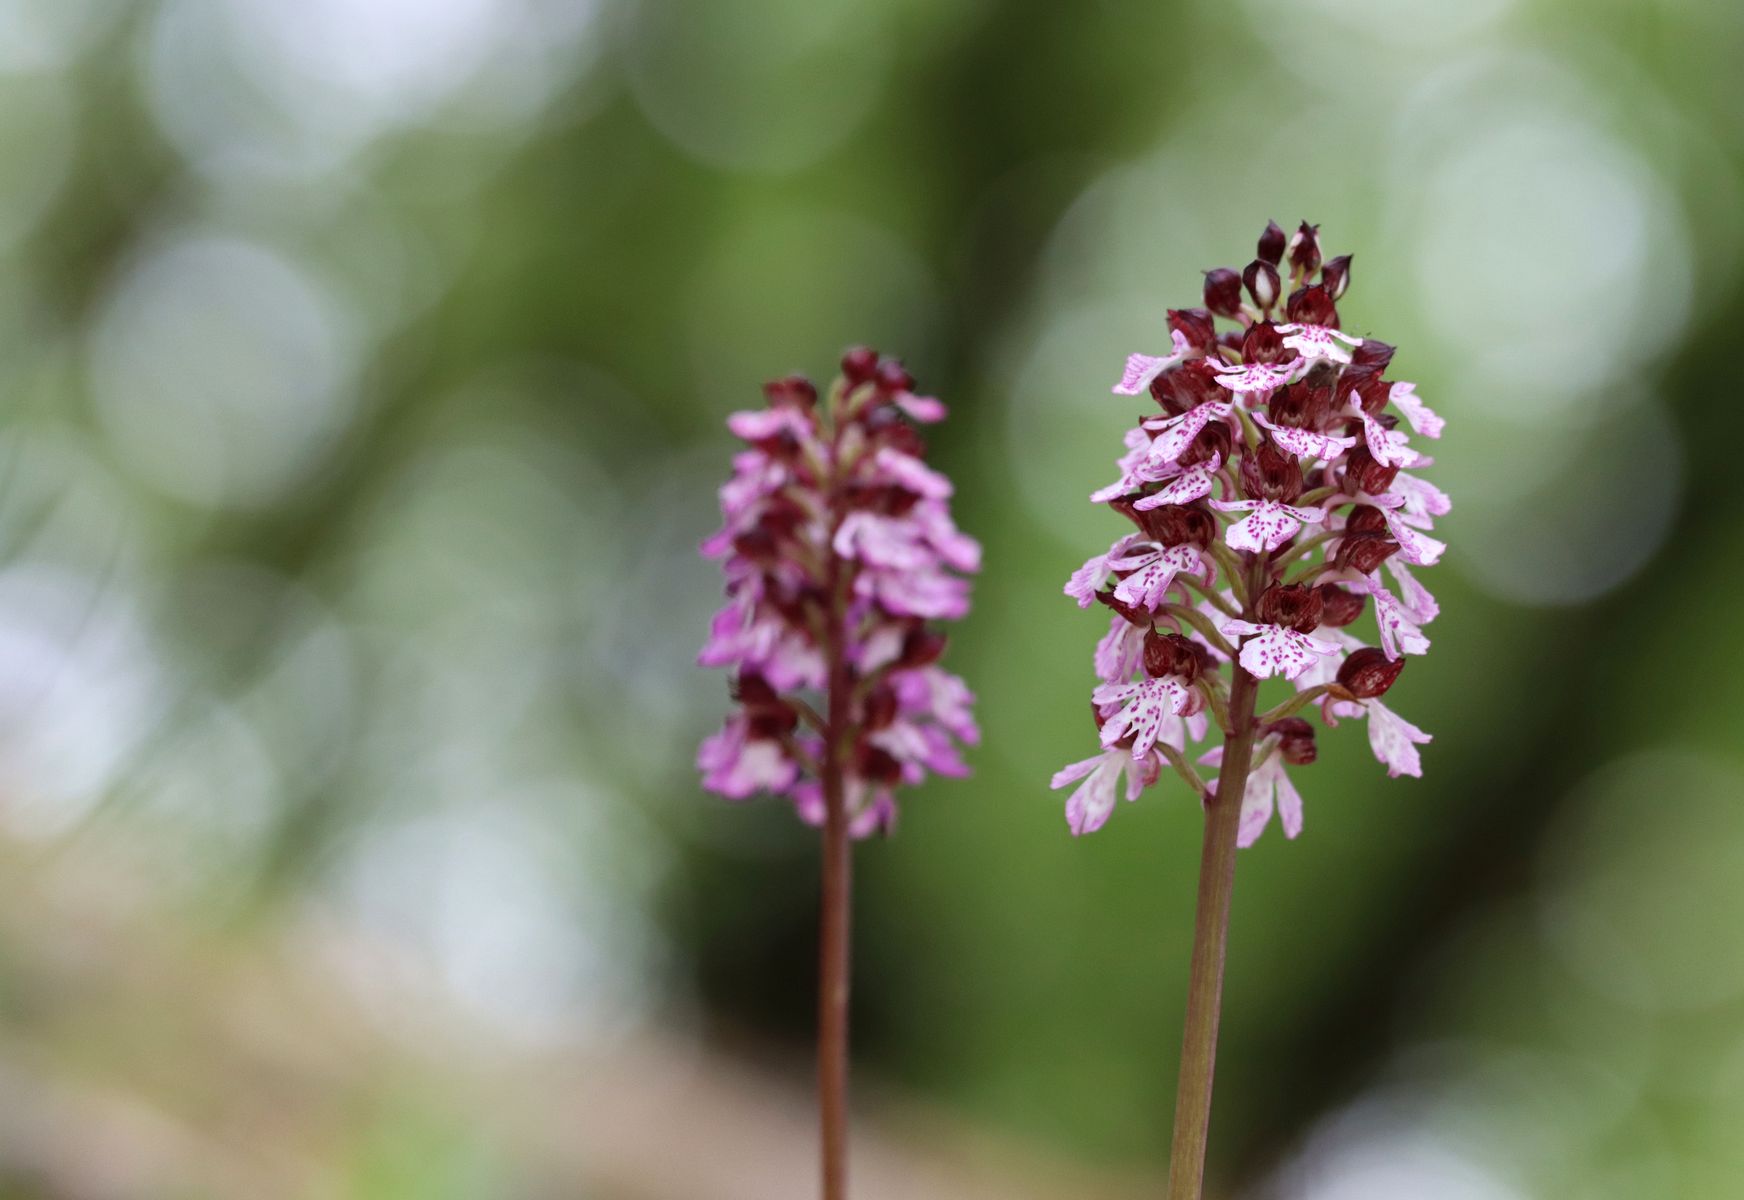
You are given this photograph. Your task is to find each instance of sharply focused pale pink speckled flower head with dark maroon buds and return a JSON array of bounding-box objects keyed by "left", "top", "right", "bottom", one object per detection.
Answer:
[{"left": 1053, "top": 223, "right": 1449, "bottom": 846}]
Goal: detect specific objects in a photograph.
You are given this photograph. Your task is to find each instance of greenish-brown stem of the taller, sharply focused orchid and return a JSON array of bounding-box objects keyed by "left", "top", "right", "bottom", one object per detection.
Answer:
[{"left": 1168, "top": 560, "right": 1264, "bottom": 1200}]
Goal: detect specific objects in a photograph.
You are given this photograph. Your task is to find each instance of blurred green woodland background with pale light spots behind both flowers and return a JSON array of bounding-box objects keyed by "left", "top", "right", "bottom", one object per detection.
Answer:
[{"left": 0, "top": 0, "right": 1744, "bottom": 1200}]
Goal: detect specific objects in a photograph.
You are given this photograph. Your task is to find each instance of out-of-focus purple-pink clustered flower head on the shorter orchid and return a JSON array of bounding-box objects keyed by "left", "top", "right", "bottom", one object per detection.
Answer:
[{"left": 698, "top": 347, "right": 980, "bottom": 837}]
